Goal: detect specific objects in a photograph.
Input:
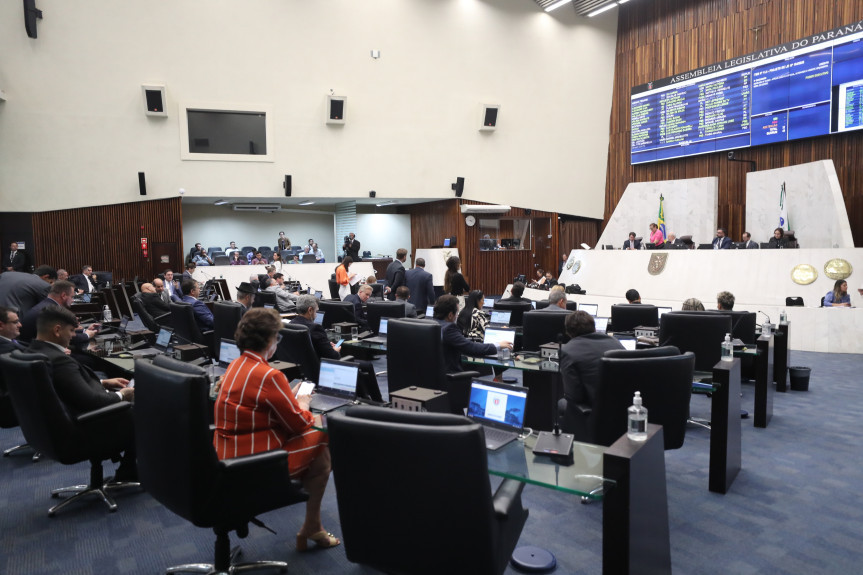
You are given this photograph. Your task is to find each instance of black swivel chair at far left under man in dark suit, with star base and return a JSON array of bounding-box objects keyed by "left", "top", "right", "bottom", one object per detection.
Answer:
[{"left": 0, "top": 351, "right": 140, "bottom": 517}]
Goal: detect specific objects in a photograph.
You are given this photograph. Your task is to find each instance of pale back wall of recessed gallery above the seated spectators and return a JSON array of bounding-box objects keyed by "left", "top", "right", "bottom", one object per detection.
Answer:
[{"left": 183, "top": 204, "right": 342, "bottom": 262}]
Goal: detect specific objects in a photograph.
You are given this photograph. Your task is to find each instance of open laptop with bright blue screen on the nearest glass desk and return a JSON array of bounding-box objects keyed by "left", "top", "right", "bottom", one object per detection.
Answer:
[{"left": 467, "top": 379, "right": 528, "bottom": 451}]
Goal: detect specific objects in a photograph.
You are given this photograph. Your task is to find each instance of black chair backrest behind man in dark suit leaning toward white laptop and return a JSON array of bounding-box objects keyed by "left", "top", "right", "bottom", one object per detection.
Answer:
[{"left": 387, "top": 319, "right": 446, "bottom": 394}]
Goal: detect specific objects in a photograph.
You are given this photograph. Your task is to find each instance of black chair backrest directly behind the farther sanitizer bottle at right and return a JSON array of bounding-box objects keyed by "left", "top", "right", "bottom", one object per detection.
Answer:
[{"left": 659, "top": 311, "right": 731, "bottom": 371}]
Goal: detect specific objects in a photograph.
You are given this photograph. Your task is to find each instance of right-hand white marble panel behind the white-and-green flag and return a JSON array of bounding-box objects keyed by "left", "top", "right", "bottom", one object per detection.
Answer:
[{"left": 746, "top": 160, "right": 854, "bottom": 248}]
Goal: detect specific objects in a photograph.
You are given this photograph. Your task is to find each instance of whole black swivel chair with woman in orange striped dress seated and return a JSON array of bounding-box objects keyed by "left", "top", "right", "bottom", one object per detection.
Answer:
[{"left": 135, "top": 358, "right": 308, "bottom": 573}]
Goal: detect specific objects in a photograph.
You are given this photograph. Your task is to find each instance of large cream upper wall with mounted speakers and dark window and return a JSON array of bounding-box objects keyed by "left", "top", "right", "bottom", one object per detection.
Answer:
[{"left": 0, "top": 0, "right": 617, "bottom": 218}]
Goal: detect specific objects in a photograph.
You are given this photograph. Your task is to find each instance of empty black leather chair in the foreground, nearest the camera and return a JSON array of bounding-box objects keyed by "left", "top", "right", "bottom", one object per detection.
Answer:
[{"left": 328, "top": 407, "right": 528, "bottom": 575}]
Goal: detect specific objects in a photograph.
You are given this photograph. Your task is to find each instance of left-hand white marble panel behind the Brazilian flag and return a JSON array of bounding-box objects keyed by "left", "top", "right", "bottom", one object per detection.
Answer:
[{"left": 596, "top": 178, "right": 719, "bottom": 249}]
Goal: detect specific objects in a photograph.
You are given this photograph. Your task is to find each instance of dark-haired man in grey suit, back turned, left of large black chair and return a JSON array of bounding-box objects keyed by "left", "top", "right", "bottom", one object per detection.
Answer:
[{"left": 558, "top": 311, "right": 623, "bottom": 432}]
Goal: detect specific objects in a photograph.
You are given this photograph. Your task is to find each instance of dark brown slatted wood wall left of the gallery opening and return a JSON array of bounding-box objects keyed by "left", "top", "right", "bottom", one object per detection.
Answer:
[{"left": 32, "top": 198, "right": 183, "bottom": 280}]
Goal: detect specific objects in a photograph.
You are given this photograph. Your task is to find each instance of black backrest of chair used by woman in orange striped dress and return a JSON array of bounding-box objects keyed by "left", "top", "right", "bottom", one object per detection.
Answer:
[{"left": 134, "top": 358, "right": 218, "bottom": 519}]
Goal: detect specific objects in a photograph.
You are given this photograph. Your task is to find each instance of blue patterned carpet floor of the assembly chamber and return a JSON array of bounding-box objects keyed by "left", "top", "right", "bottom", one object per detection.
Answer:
[{"left": 0, "top": 352, "right": 863, "bottom": 575}]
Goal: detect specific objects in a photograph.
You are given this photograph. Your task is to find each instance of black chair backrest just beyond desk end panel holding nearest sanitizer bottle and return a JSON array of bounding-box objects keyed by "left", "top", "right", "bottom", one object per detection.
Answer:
[{"left": 593, "top": 350, "right": 695, "bottom": 449}]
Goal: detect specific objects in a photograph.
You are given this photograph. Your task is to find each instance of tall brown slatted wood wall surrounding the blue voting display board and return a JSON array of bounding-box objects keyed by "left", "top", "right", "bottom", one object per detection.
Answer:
[{"left": 605, "top": 0, "right": 863, "bottom": 247}]
